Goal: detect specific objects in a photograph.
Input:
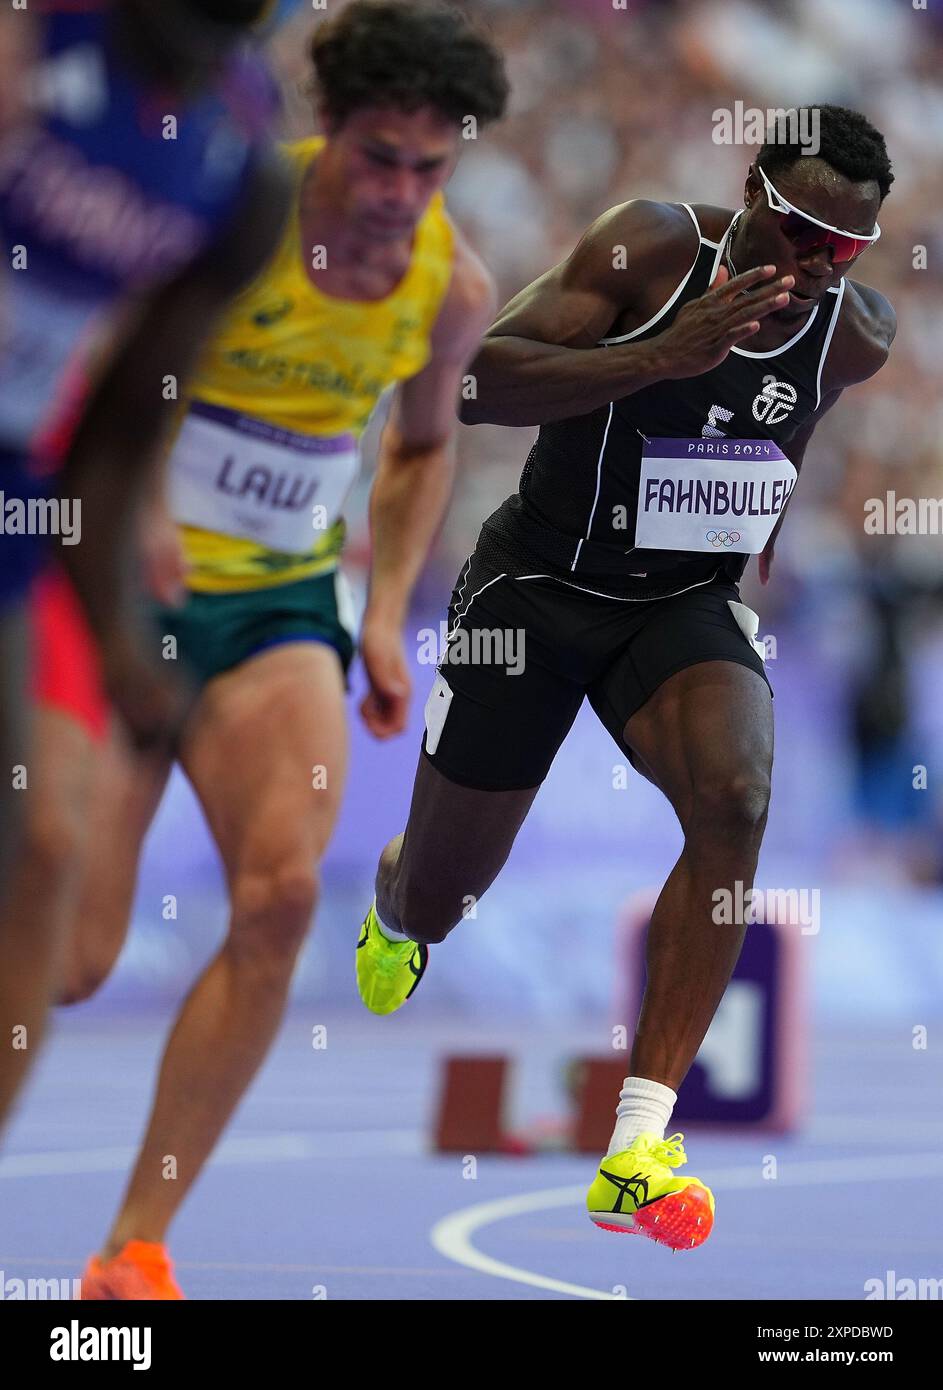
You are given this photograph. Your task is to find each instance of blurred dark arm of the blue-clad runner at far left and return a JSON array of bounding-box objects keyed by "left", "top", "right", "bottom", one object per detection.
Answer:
[{"left": 58, "top": 154, "right": 289, "bottom": 742}]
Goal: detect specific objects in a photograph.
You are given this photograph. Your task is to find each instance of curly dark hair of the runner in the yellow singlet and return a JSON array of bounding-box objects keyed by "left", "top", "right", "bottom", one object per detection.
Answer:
[{"left": 310, "top": 0, "right": 509, "bottom": 125}]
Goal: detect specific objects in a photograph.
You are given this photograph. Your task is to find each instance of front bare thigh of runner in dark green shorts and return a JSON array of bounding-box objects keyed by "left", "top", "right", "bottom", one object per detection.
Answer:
[{"left": 181, "top": 641, "right": 348, "bottom": 878}]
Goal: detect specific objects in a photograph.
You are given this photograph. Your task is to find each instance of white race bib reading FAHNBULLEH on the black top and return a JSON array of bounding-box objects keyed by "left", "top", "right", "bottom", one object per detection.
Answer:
[{"left": 636, "top": 439, "right": 797, "bottom": 555}]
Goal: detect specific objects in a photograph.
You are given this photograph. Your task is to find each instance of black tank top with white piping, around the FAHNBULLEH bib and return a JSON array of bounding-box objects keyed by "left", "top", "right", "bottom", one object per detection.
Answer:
[{"left": 480, "top": 203, "right": 844, "bottom": 598}]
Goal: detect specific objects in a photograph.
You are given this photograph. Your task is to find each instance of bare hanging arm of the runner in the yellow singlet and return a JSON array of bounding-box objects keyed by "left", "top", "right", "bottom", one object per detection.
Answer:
[{"left": 360, "top": 232, "right": 497, "bottom": 738}]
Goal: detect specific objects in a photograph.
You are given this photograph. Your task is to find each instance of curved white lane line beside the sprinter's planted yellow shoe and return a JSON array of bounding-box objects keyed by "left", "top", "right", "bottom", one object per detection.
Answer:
[{"left": 430, "top": 1154, "right": 943, "bottom": 1301}]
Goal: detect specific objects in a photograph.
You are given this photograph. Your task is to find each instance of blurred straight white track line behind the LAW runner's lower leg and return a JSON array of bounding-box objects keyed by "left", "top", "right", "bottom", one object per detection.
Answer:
[{"left": 0, "top": 1130, "right": 424, "bottom": 1179}]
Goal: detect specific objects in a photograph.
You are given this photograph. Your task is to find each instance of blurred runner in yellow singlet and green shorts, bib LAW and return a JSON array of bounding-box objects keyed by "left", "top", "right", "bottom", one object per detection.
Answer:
[{"left": 65, "top": 0, "right": 506, "bottom": 1298}]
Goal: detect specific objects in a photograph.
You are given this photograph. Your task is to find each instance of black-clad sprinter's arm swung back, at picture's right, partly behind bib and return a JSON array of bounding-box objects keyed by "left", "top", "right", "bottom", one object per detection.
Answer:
[{"left": 759, "top": 281, "right": 897, "bottom": 584}]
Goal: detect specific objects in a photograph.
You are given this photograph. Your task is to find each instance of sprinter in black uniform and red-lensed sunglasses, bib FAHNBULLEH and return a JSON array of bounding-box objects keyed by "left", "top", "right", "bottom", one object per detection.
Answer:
[{"left": 360, "top": 107, "right": 894, "bottom": 1248}]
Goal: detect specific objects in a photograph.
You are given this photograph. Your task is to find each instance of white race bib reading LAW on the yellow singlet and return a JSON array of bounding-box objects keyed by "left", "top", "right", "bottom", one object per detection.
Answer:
[{"left": 170, "top": 400, "right": 360, "bottom": 555}]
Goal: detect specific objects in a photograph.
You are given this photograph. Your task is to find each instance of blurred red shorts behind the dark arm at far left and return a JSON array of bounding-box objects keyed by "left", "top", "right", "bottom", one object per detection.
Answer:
[{"left": 29, "top": 566, "right": 110, "bottom": 741}]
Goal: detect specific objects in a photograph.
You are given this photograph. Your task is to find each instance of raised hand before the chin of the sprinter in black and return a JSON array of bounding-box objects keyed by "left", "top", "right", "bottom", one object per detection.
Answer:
[{"left": 651, "top": 265, "right": 796, "bottom": 381}]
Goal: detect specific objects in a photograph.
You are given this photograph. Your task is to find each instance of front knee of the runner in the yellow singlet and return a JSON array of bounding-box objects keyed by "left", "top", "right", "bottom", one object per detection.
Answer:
[{"left": 231, "top": 859, "right": 320, "bottom": 962}]
